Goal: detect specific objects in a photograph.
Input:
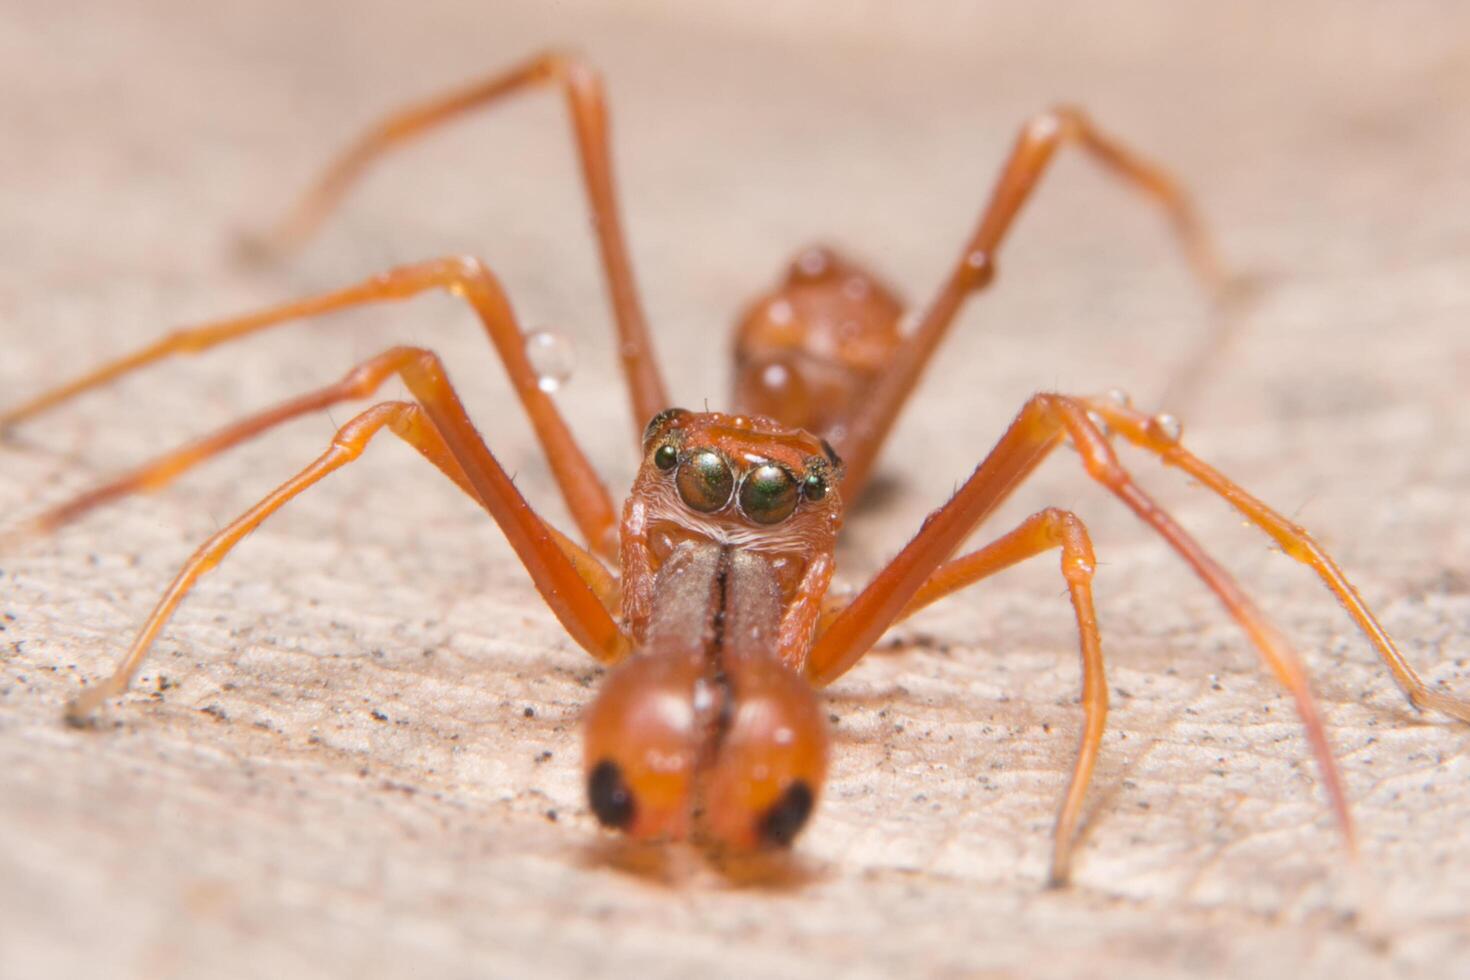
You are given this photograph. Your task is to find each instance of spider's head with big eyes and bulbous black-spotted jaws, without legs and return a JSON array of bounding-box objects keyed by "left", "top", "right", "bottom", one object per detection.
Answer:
[{"left": 587, "top": 408, "right": 842, "bottom": 848}]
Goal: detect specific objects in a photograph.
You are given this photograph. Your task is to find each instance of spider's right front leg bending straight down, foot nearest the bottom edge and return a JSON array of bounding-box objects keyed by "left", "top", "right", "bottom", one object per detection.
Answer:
[{"left": 870, "top": 507, "right": 1107, "bottom": 884}]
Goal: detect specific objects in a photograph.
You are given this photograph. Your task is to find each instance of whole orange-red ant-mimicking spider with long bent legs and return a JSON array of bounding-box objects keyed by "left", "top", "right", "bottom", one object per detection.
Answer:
[{"left": 14, "top": 54, "right": 1470, "bottom": 883}]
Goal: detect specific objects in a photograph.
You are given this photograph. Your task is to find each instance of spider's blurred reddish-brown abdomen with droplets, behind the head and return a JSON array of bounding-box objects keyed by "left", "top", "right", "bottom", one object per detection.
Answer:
[{"left": 735, "top": 247, "right": 903, "bottom": 441}]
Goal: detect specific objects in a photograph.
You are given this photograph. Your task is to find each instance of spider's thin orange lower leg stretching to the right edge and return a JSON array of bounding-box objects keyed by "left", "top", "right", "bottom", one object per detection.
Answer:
[{"left": 1083, "top": 398, "right": 1470, "bottom": 721}]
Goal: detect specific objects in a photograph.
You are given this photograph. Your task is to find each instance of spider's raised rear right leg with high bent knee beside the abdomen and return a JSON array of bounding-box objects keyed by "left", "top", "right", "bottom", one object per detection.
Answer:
[{"left": 838, "top": 106, "right": 1226, "bottom": 500}]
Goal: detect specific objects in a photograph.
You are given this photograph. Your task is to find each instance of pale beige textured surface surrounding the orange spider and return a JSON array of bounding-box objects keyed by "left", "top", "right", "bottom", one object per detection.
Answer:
[{"left": 0, "top": 0, "right": 1470, "bottom": 979}]
